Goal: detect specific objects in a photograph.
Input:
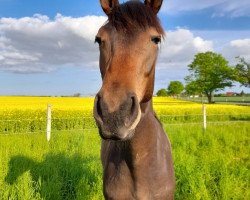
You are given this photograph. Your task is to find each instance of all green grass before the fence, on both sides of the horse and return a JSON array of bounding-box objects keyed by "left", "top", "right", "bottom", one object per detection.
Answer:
[{"left": 0, "top": 123, "right": 250, "bottom": 200}]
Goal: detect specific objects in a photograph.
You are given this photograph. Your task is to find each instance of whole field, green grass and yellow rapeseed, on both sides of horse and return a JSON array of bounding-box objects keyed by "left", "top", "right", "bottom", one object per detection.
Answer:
[{"left": 0, "top": 97, "right": 250, "bottom": 200}]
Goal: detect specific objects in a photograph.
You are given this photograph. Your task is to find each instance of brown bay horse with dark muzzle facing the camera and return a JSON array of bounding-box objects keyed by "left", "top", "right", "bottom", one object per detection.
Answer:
[{"left": 94, "top": 0, "right": 175, "bottom": 200}]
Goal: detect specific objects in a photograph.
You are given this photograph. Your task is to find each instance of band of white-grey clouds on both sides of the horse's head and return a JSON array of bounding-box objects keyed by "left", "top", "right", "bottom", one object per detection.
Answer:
[{"left": 0, "top": 14, "right": 250, "bottom": 79}]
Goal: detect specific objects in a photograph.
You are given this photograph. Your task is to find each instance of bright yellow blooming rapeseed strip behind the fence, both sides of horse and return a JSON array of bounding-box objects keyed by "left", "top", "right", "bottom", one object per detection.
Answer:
[{"left": 0, "top": 96, "right": 250, "bottom": 118}]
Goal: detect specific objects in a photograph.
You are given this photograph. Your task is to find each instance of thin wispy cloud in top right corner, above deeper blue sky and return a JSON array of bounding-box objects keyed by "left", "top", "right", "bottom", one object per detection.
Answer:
[{"left": 162, "top": 0, "right": 250, "bottom": 17}]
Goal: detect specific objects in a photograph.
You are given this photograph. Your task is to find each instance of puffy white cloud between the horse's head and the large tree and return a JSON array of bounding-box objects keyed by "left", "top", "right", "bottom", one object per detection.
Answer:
[{"left": 155, "top": 29, "right": 213, "bottom": 91}]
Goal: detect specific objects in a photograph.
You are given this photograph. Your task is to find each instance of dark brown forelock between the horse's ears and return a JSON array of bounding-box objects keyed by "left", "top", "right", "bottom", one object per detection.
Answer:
[{"left": 109, "top": 1, "right": 164, "bottom": 36}]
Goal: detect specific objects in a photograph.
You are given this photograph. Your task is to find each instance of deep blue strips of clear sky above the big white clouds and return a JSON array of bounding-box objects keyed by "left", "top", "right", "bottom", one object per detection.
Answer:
[{"left": 0, "top": 0, "right": 250, "bottom": 30}]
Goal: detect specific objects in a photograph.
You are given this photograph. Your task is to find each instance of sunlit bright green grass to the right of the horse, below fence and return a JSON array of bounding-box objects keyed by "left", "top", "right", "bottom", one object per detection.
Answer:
[{"left": 167, "top": 123, "right": 250, "bottom": 200}]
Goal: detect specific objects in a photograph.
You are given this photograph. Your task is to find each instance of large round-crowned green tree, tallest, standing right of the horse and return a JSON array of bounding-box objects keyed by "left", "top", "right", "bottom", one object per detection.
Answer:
[{"left": 185, "top": 52, "right": 234, "bottom": 103}]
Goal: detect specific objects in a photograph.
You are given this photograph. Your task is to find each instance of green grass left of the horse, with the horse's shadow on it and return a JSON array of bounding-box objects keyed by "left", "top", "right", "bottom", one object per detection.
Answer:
[{"left": 0, "top": 131, "right": 102, "bottom": 200}]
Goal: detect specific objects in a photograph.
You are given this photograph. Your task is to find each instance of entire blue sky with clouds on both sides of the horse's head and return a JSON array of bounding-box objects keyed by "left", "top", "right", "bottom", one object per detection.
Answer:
[{"left": 0, "top": 0, "right": 250, "bottom": 95}]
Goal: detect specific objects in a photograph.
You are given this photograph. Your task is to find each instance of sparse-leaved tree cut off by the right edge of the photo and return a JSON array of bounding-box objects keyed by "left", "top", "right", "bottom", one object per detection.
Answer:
[{"left": 234, "top": 57, "right": 250, "bottom": 87}]
